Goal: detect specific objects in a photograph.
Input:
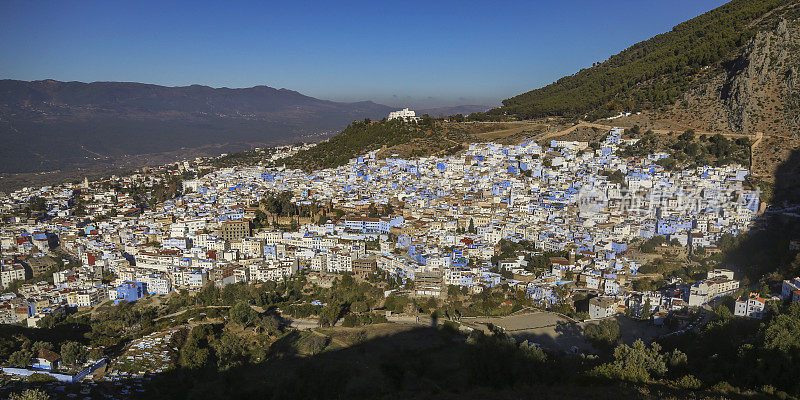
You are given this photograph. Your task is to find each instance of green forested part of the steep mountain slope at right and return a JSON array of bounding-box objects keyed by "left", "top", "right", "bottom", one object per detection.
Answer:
[{"left": 484, "top": 0, "right": 796, "bottom": 119}]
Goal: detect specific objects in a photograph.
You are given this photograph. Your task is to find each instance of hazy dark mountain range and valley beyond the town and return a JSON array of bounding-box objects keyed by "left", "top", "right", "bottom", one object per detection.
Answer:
[{"left": 0, "top": 80, "right": 393, "bottom": 173}]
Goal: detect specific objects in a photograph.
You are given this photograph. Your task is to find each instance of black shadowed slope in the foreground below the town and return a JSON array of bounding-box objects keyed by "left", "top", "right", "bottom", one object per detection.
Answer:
[{"left": 0, "top": 328, "right": 776, "bottom": 400}]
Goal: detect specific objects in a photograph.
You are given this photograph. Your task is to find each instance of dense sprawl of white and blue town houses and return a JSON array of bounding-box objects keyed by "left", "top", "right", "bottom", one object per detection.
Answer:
[{"left": 0, "top": 129, "right": 788, "bottom": 325}]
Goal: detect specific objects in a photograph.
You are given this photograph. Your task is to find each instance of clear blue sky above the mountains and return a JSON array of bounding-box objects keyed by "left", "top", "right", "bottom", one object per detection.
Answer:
[{"left": 0, "top": 0, "right": 725, "bottom": 107}]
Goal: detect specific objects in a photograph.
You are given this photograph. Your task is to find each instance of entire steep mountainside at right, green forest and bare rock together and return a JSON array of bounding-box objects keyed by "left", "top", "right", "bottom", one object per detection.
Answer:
[{"left": 482, "top": 0, "right": 800, "bottom": 188}]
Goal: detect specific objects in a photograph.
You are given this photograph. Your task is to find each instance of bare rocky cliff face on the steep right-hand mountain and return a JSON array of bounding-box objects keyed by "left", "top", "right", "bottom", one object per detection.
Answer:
[{"left": 664, "top": 10, "right": 800, "bottom": 179}]
